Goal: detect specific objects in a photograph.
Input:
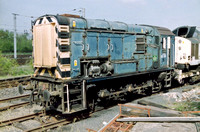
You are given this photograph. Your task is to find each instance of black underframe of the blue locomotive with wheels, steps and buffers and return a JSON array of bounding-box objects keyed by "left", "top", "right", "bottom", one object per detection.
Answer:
[{"left": 30, "top": 68, "right": 173, "bottom": 114}]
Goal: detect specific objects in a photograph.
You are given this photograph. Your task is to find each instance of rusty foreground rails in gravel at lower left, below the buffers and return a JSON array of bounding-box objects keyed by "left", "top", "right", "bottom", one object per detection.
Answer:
[{"left": 0, "top": 94, "right": 89, "bottom": 132}]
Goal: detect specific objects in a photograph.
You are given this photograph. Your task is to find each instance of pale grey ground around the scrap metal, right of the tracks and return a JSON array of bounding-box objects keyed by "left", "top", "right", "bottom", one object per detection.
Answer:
[{"left": 52, "top": 83, "right": 200, "bottom": 132}]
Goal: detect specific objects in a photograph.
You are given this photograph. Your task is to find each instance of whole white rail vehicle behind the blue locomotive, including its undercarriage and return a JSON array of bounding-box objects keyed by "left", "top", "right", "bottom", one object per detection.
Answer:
[{"left": 173, "top": 26, "right": 200, "bottom": 84}]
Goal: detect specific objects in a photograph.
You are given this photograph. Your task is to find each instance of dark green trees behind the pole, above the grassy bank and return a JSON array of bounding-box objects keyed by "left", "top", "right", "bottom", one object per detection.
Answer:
[{"left": 0, "top": 30, "right": 32, "bottom": 53}]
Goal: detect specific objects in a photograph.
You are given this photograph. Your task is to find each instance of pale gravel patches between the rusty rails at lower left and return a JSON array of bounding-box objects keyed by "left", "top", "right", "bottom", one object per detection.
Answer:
[{"left": 0, "top": 87, "right": 42, "bottom": 132}]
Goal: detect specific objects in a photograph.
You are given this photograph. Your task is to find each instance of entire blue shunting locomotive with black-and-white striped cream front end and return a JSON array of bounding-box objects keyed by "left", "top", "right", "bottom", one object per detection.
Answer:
[{"left": 22, "top": 14, "right": 175, "bottom": 114}]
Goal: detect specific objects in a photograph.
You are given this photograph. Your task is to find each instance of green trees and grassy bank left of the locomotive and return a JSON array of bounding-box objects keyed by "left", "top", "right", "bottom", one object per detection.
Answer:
[{"left": 0, "top": 30, "right": 33, "bottom": 78}]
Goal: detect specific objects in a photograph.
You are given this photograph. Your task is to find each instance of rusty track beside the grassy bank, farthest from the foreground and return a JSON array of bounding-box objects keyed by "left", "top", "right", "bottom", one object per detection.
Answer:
[{"left": 0, "top": 75, "right": 31, "bottom": 89}]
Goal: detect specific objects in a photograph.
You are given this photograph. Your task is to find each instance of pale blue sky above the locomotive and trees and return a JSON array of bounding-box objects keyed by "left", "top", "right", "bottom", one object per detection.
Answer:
[{"left": 0, "top": 0, "right": 200, "bottom": 33}]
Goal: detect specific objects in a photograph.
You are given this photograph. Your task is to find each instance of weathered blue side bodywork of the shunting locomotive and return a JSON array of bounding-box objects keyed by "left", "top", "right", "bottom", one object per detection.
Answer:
[{"left": 63, "top": 18, "right": 174, "bottom": 78}]
